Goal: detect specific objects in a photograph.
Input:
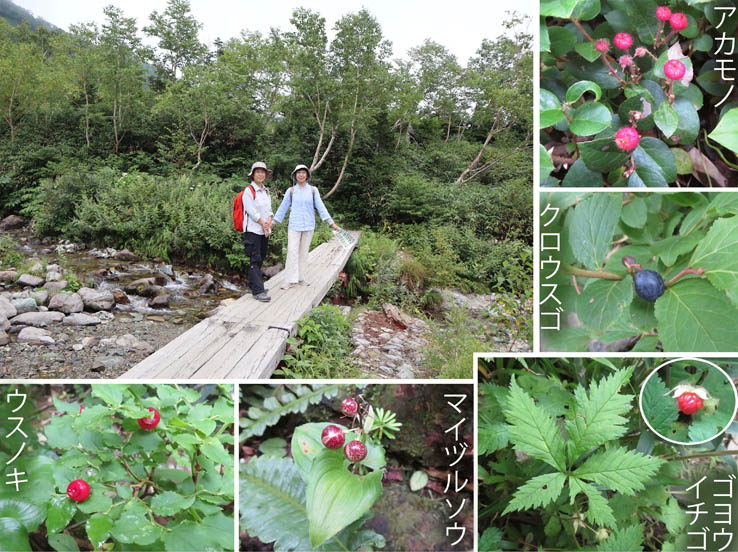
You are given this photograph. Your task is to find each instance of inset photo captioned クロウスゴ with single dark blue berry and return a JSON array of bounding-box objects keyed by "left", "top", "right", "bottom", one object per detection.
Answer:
[{"left": 538, "top": 191, "right": 738, "bottom": 353}]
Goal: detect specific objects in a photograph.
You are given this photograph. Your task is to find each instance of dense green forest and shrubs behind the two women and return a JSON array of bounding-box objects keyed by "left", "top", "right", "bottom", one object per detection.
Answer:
[{"left": 0, "top": 0, "right": 533, "bottom": 370}]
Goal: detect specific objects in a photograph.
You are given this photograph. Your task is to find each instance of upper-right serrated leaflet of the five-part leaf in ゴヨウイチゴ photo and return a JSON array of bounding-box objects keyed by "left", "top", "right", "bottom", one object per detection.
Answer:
[{"left": 565, "top": 366, "right": 633, "bottom": 463}]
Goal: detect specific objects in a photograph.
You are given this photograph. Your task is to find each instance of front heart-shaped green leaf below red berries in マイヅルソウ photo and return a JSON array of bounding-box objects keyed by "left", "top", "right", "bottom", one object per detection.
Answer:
[{"left": 305, "top": 449, "right": 383, "bottom": 546}]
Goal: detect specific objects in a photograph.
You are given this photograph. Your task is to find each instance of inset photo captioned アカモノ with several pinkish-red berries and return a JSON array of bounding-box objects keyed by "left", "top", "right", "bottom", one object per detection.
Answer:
[{"left": 538, "top": 0, "right": 738, "bottom": 188}]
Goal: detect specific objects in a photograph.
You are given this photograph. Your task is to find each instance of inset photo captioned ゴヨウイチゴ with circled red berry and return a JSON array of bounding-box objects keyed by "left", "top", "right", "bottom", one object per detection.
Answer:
[{"left": 477, "top": 355, "right": 738, "bottom": 552}]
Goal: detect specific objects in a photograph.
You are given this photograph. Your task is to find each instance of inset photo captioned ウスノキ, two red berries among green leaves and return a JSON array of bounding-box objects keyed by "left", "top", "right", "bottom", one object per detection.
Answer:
[{"left": 0, "top": 384, "right": 235, "bottom": 552}]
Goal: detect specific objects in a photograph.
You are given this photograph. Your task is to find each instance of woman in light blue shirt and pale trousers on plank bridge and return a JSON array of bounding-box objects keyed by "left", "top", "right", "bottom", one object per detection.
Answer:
[{"left": 272, "top": 165, "right": 338, "bottom": 289}]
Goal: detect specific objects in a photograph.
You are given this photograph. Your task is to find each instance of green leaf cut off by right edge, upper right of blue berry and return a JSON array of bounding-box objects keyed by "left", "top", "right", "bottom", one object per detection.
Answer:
[{"left": 689, "top": 216, "right": 738, "bottom": 305}]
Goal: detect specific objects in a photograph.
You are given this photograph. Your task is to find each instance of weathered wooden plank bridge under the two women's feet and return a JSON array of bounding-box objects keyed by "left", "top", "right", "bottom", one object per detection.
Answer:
[{"left": 120, "top": 232, "right": 359, "bottom": 379}]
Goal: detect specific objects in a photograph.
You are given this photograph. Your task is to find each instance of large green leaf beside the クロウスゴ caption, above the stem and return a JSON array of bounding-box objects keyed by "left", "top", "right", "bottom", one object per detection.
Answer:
[{"left": 569, "top": 194, "right": 621, "bottom": 269}]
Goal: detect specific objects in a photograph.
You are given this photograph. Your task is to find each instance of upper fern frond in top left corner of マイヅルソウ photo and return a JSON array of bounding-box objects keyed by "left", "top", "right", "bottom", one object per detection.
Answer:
[{"left": 240, "top": 385, "right": 338, "bottom": 443}]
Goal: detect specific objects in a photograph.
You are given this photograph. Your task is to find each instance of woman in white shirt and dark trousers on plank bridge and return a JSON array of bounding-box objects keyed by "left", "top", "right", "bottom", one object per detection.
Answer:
[{"left": 242, "top": 161, "right": 274, "bottom": 303}]
